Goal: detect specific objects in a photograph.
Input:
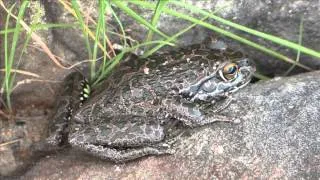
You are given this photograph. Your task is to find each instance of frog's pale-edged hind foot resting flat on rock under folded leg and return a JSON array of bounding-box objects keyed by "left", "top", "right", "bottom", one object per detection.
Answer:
[{"left": 72, "top": 143, "right": 174, "bottom": 163}]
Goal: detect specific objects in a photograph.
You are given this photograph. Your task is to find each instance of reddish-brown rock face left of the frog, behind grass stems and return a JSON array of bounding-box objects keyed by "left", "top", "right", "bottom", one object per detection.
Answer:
[{"left": 0, "top": 0, "right": 75, "bottom": 176}]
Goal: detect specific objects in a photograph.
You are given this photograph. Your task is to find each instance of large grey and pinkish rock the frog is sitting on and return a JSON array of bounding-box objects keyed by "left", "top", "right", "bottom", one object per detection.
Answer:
[{"left": 20, "top": 71, "right": 320, "bottom": 179}]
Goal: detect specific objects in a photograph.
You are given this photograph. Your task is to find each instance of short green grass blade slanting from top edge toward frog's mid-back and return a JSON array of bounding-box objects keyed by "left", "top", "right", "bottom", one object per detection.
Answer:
[{"left": 111, "top": 0, "right": 169, "bottom": 39}]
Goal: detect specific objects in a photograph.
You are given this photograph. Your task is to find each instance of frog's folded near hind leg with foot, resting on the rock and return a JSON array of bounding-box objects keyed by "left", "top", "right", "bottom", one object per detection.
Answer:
[{"left": 69, "top": 115, "right": 173, "bottom": 163}]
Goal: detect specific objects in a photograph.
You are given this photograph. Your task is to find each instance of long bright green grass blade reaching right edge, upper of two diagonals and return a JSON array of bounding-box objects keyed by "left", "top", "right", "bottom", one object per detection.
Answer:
[{"left": 171, "top": 1, "right": 320, "bottom": 58}]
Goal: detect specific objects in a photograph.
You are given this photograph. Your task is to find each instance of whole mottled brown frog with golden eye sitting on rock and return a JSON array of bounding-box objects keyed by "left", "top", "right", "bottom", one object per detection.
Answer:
[{"left": 48, "top": 46, "right": 255, "bottom": 162}]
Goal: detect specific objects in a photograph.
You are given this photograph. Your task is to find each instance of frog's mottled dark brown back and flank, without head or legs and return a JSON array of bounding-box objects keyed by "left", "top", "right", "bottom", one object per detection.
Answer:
[{"left": 78, "top": 45, "right": 242, "bottom": 124}]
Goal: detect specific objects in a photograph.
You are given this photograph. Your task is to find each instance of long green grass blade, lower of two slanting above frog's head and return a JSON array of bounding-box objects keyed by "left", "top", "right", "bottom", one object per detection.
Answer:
[{"left": 130, "top": 1, "right": 312, "bottom": 70}]
